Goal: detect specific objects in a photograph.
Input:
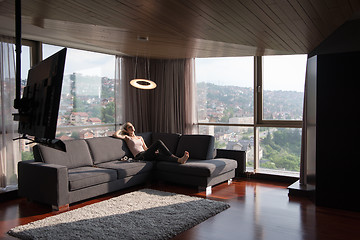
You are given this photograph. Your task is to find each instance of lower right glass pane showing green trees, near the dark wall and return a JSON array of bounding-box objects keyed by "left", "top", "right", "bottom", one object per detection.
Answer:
[{"left": 259, "top": 127, "right": 301, "bottom": 173}]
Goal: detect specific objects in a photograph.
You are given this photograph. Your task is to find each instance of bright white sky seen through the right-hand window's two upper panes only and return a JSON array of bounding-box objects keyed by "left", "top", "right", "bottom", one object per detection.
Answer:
[{"left": 195, "top": 55, "right": 307, "bottom": 92}]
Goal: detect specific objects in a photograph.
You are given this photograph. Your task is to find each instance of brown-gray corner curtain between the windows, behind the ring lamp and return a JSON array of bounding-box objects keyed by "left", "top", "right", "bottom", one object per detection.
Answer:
[{"left": 121, "top": 57, "right": 196, "bottom": 134}]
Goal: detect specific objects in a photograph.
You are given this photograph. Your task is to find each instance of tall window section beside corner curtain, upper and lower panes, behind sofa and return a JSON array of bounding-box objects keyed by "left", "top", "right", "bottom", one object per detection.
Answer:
[{"left": 195, "top": 57, "right": 254, "bottom": 167}]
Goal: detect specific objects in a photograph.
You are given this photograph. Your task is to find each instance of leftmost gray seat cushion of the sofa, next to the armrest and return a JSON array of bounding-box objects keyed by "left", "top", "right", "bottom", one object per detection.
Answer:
[{"left": 68, "top": 167, "right": 117, "bottom": 191}]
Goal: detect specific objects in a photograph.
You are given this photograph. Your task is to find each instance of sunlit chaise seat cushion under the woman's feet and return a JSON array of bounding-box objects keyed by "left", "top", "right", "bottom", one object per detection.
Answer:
[{"left": 157, "top": 158, "right": 237, "bottom": 177}]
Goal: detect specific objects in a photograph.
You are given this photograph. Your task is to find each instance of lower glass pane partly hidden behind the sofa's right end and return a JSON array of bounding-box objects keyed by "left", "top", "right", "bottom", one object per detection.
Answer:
[{"left": 199, "top": 126, "right": 254, "bottom": 171}]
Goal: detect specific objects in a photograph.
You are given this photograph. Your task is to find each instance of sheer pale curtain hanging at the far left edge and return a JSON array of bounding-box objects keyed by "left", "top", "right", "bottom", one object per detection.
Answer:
[{"left": 0, "top": 36, "right": 20, "bottom": 189}]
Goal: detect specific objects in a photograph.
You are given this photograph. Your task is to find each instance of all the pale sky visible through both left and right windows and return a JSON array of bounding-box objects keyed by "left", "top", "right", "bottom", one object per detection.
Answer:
[{"left": 21, "top": 44, "right": 307, "bottom": 92}]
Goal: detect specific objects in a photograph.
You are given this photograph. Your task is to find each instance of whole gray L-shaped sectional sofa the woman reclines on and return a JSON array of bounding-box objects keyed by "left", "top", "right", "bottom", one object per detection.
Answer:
[{"left": 18, "top": 132, "right": 245, "bottom": 209}]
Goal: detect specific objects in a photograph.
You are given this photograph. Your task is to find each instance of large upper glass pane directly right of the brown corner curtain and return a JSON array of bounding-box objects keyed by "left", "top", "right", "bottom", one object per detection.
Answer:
[{"left": 195, "top": 57, "right": 254, "bottom": 124}]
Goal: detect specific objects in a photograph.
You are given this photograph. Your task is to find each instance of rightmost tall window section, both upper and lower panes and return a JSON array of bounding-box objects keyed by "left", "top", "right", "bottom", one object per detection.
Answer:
[{"left": 257, "top": 55, "right": 307, "bottom": 175}]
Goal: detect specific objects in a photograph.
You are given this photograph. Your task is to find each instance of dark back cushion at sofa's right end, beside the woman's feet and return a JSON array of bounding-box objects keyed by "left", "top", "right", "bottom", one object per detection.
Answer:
[{"left": 175, "top": 135, "right": 215, "bottom": 160}]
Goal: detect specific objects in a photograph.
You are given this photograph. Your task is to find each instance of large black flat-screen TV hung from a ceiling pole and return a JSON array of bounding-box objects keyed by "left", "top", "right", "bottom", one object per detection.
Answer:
[{"left": 18, "top": 48, "right": 66, "bottom": 139}]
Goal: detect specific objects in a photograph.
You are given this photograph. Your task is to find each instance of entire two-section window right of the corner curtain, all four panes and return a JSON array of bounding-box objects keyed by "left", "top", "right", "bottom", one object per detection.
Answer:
[{"left": 196, "top": 55, "right": 307, "bottom": 176}]
